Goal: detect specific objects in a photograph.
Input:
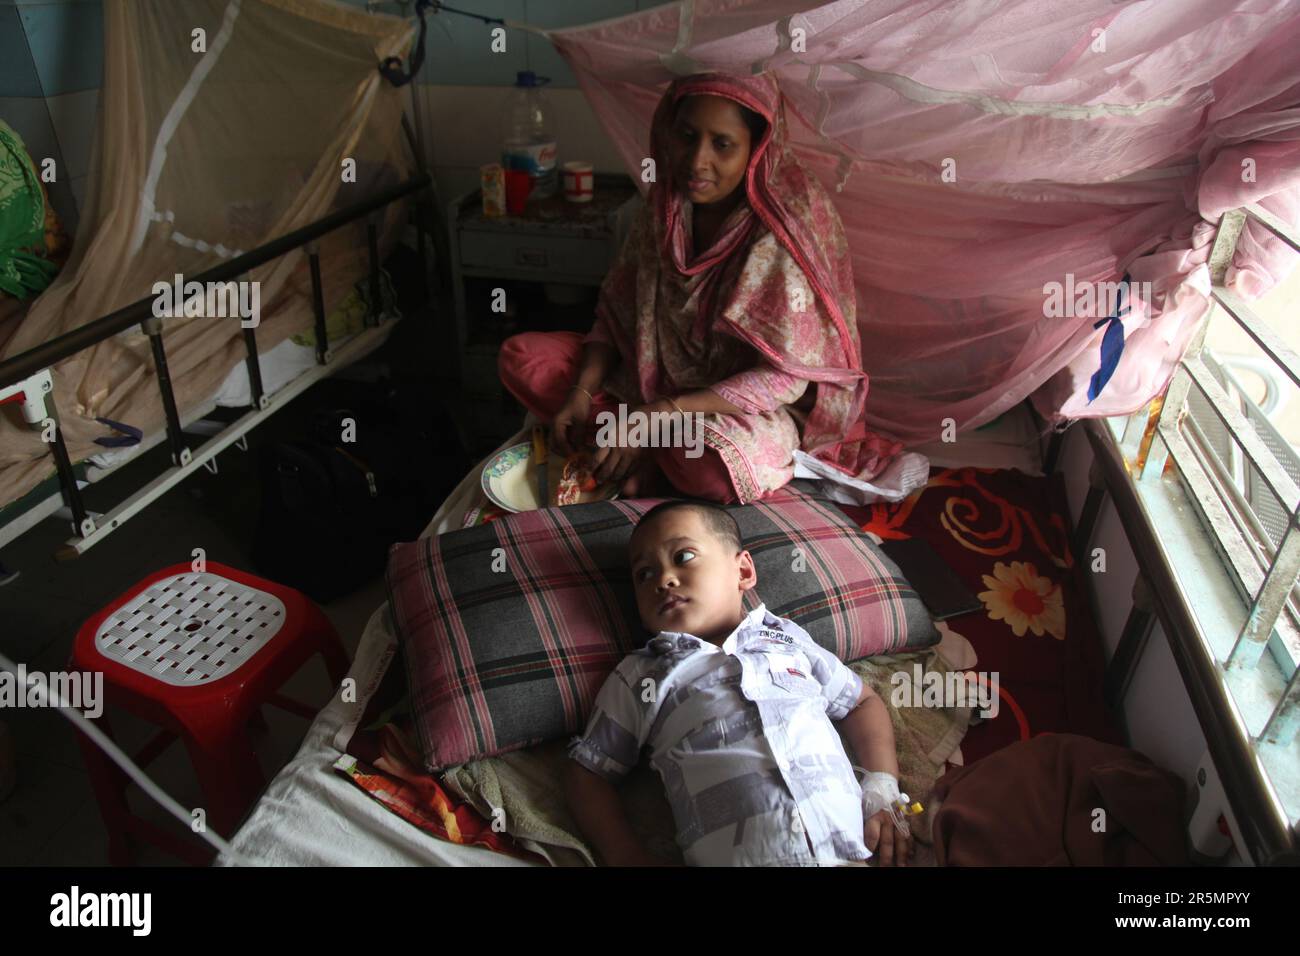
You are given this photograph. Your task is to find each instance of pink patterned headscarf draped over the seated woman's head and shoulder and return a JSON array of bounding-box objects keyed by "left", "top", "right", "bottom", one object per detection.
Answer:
[{"left": 642, "top": 73, "right": 902, "bottom": 479}]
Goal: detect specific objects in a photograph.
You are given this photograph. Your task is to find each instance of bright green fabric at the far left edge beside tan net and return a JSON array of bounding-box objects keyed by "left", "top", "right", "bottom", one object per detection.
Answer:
[{"left": 0, "top": 120, "right": 59, "bottom": 299}]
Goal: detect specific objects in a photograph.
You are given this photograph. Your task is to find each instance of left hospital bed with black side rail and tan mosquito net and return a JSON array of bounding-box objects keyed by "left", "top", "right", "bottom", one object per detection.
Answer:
[{"left": 0, "top": 3, "right": 441, "bottom": 555}]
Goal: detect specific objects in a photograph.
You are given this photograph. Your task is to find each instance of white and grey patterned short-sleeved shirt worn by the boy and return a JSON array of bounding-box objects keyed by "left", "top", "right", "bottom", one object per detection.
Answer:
[{"left": 568, "top": 605, "right": 871, "bottom": 866}]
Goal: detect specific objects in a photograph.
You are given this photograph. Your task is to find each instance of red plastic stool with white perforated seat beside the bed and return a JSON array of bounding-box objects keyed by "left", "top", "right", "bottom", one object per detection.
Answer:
[{"left": 70, "top": 562, "right": 348, "bottom": 866}]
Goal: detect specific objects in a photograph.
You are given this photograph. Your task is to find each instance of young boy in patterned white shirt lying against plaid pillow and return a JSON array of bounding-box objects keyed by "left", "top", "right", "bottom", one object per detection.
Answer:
[{"left": 564, "top": 499, "right": 911, "bottom": 866}]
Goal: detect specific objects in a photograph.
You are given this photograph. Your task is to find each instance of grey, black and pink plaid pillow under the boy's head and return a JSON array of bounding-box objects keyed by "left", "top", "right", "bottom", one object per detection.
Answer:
[{"left": 387, "top": 485, "right": 939, "bottom": 771}]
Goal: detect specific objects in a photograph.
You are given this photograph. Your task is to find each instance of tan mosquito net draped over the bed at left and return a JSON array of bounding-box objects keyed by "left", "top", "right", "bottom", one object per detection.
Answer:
[{"left": 0, "top": 0, "right": 413, "bottom": 502}]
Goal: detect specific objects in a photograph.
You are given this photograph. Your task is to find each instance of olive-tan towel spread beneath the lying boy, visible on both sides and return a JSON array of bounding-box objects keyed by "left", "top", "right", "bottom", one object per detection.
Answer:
[{"left": 442, "top": 645, "right": 971, "bottom": 866}]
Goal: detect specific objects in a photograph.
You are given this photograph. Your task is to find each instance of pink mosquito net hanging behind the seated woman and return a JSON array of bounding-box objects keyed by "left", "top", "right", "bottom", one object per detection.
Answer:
[{"left": 543, "top": 0, "right": 1300, "bottom": 441}]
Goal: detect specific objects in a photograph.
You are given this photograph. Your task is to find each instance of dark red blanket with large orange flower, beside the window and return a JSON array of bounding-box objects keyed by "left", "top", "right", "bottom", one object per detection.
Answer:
[{"left": 844, "top": 468, "right": 1125, "bottom": 762}]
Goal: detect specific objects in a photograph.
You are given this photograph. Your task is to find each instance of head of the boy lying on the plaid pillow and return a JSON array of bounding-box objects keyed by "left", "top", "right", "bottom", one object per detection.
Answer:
[{"left": 628, "top": 499, "right": 758, "bottom": 644}]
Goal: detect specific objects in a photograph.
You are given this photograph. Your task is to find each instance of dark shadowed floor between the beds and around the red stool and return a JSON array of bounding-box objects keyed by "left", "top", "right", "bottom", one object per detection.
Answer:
[{"left": 0, "top": 261, "right": 553, "bottom": 866}]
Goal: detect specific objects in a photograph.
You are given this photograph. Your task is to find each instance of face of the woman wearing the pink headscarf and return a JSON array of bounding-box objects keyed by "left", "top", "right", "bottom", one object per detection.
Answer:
[{"left": 671, "top": 95, "right": 750, "bottom": 208}]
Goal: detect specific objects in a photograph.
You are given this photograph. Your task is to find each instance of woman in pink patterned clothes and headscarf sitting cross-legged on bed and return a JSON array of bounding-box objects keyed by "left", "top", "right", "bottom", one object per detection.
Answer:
[{"left": 499, "top": 73, "right": 900, "bottom": 503}]
